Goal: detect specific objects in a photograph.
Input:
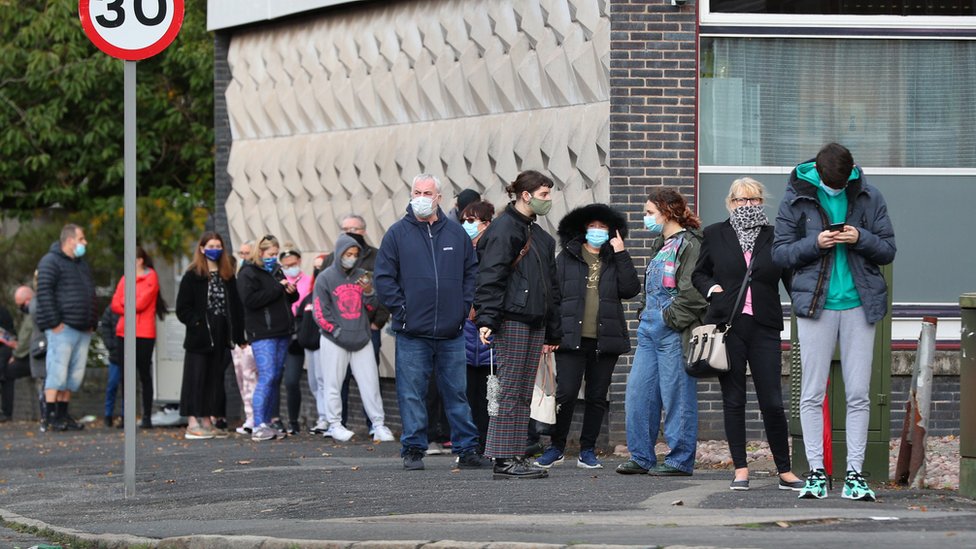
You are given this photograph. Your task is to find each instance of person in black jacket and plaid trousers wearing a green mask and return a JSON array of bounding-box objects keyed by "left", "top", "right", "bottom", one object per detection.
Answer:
[{"left": 474, "top": 171, "right": 562, "bottom": 478}]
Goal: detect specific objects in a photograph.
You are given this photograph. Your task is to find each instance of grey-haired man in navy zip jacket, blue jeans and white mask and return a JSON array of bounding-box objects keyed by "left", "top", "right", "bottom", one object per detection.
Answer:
[{"left": 375, "top": 174, "right": 492, "bottom": 470}]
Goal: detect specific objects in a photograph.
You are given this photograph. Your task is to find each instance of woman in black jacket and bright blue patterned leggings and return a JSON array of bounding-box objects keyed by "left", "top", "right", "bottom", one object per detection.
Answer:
[{"left": 237, "top": 235, "right": 298, "bottom": 442}]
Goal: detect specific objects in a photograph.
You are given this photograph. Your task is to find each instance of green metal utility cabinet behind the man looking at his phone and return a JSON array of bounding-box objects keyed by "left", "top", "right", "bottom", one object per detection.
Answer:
[{"left": 789, "top": 265, "right": 892, "bottom": 481}]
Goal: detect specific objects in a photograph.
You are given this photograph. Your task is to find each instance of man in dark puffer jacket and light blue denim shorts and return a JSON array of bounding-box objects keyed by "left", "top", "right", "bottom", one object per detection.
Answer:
[{"left": 35, "top": 223, "right": 98, "bottom": 431}]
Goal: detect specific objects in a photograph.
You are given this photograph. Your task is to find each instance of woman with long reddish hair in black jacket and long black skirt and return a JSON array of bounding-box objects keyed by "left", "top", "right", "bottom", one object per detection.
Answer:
[{"left": 176, "top": 232, "right": 244, "bottom": 440}]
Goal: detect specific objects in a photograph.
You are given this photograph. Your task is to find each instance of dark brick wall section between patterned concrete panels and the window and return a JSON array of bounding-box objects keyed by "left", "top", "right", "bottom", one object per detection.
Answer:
[{"left": 609, "top": 0, "right": 696, "bottom": 444}]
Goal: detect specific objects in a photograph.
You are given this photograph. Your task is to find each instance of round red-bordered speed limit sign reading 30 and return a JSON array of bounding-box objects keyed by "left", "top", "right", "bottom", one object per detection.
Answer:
[{"left": 78, "top": 0, "right": 183, "bottom": 61}]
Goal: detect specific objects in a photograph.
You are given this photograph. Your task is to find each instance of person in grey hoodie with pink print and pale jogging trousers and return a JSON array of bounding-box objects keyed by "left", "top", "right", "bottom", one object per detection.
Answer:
[{"left": 312, "top": 233, "right": 393, "bottom": 441}]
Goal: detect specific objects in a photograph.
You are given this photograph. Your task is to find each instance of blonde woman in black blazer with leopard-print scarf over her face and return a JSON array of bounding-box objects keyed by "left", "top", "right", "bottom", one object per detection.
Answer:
[{"left": 692, "top": 177, "right": 803, "bottom": 490}]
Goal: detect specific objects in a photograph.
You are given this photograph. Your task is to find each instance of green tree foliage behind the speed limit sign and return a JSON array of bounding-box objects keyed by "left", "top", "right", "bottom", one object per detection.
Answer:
[{"left": 0, "top": 0, "right": 214, "bottom": 256}]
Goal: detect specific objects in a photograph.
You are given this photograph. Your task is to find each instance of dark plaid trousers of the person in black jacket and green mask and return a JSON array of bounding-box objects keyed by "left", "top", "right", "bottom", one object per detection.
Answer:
[{"left": 485, "top": 320, "right": 545, "bottom": 458}]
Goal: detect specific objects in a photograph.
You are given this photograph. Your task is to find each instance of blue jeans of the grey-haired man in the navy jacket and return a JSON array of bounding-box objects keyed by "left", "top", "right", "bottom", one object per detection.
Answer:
[{"left": 396, "top": 334, "right": 478, "bottom": 456}]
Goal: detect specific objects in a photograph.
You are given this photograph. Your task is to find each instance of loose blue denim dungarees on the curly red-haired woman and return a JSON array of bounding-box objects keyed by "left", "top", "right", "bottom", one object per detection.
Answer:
[{"left": 624, "top": 306, "right": 698, "bottom": 473}]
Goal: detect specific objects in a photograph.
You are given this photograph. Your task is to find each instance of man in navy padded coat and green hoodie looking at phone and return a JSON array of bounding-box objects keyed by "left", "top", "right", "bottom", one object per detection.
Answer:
[{"left": 773, "top": 143, "right": 895, "bottom": 501}]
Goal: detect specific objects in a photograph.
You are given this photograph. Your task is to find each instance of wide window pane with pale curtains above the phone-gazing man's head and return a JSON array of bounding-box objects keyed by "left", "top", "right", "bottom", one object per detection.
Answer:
[{"left": 699, "top": 37, "right": 976, "bottom": 168}]
